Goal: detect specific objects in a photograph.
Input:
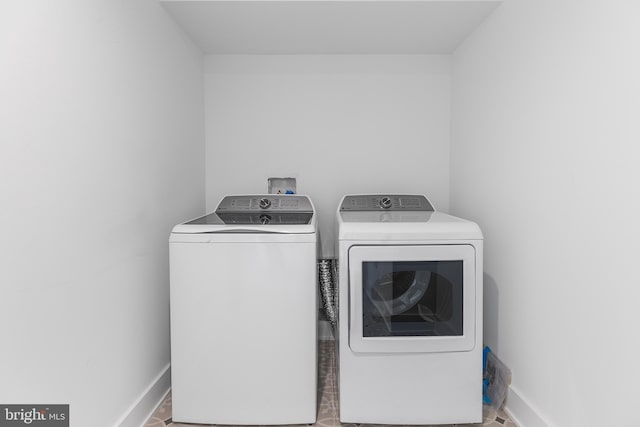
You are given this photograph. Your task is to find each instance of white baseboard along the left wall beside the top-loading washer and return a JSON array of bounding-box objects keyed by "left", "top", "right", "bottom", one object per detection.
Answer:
[{"left": 115, "top": 364, "right": 171, "bottom": 427}]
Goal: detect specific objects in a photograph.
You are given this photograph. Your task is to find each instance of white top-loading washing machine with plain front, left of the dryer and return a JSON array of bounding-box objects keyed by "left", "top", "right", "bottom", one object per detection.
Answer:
[{"left": 169, "top": 195, "right": 318, "bottom": 425}]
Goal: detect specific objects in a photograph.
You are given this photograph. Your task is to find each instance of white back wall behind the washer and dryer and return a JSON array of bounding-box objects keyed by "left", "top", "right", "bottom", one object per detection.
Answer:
[{"left": 205, "top": 55, "right": 450, "bottom": 256}]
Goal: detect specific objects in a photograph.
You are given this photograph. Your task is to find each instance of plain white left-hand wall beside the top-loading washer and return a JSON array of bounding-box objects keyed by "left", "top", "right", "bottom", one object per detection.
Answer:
[{"left": 0, "top": 0, "right": 204, "bottom": 426}]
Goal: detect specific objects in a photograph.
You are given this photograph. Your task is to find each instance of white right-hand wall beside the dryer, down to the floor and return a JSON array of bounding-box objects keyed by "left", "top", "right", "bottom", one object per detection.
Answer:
[{"left": 451, "top": 0, "right": 640, "bottom": 427}]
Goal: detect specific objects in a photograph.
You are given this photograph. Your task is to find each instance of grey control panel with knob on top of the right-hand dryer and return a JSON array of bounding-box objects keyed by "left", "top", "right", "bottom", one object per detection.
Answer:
[{"left": 340, "top": 194, "right": 434, "bottom": 212}]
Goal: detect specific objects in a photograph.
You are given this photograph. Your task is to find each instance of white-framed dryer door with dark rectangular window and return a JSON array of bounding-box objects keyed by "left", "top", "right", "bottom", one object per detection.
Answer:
[{"left": 349, "top": 245, "right": 476, "bottom": 353}]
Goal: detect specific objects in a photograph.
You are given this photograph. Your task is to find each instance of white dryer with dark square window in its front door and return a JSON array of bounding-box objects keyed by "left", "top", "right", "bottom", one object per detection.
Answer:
[{"left": 337, "top": 194, "right": 483, "bottom": 424}]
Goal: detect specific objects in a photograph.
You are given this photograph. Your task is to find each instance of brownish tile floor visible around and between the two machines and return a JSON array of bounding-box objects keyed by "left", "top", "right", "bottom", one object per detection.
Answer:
[{"left": 144, "top": 340, "right": 516, "bottom": 427}]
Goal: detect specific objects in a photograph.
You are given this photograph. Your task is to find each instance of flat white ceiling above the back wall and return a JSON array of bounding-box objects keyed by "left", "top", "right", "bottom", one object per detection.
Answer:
[{"left": 161, "top": 0, "right": 502, "bottom": 54}]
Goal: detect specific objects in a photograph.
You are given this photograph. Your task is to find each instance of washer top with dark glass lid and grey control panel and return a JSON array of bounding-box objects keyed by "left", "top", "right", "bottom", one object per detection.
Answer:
[{"left": 172, "top": 194, "right": 316, "bottom": 234}]
